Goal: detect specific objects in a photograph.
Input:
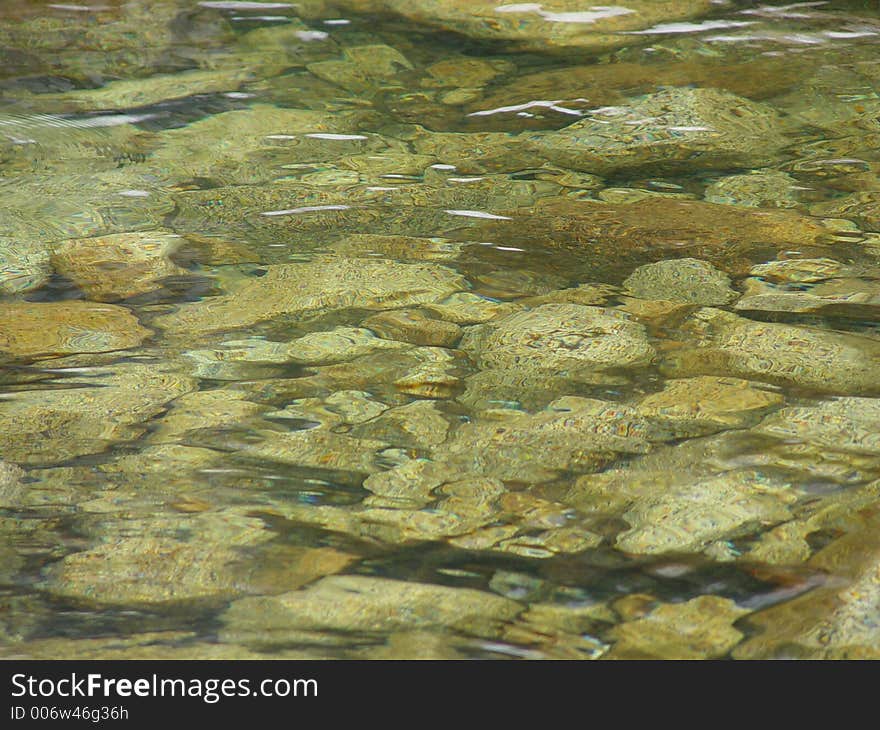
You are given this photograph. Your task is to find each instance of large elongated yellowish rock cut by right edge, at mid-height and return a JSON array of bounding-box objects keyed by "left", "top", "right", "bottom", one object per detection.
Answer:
[{"left": 662, "top": 308, "right": 880, "bottom": 395}]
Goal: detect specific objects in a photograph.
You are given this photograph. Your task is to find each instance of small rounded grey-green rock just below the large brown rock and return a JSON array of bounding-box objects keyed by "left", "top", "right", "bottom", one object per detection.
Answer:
[{"left": 623, "top": 259, "right": 738, "bottom": 306}]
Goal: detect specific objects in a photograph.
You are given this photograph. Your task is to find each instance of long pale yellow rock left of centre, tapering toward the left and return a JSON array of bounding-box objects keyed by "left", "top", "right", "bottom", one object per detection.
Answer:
[{"left": 156, "top": 258, "right": 467, "bottom": 333}]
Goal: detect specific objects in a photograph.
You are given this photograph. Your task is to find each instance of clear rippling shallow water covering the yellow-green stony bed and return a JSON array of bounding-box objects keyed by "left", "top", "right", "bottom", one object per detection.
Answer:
[{"left": 0, "top": 0, "right": 880, "bottom": 659}]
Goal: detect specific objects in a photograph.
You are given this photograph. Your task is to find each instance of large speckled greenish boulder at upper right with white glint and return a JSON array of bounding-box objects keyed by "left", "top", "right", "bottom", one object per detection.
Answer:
[{"left": 528, "top": 88, "right": 787, "bottom": 175}]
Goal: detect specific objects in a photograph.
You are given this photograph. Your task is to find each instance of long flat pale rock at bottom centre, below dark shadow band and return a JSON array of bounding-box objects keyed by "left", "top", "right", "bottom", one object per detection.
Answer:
[{"left": 221, "top": 575, "right": 522, "bottom": 646}]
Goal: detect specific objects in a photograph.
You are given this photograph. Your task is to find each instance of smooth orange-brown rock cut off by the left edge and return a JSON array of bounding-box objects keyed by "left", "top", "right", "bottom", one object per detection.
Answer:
[{"left": 0, "top": 300, "right": 152, "bottom": 358}]
